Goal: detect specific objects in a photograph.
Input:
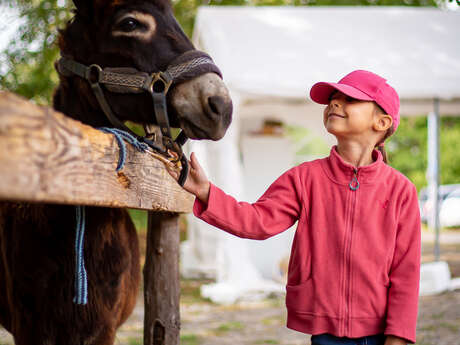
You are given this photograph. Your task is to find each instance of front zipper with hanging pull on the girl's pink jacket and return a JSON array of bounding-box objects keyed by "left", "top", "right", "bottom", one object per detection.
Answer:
[{"left": 344, "top": 168, "right": 359, "bottom": 334}]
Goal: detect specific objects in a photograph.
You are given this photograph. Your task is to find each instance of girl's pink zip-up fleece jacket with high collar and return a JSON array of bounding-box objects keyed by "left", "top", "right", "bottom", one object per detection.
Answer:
[{"left": 193, "top": 146, "right": 421, "bottom": 343}]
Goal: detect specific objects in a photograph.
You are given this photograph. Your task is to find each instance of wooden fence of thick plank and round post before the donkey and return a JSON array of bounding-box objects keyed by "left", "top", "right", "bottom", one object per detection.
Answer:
[{"left": 0, "top": 92, "right": 194, "bottom": 345}]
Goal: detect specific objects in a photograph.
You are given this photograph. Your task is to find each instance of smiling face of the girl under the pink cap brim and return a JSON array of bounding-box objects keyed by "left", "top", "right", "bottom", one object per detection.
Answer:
[{"left": 323, "top": 91, "right": 377, "bottom": 139}]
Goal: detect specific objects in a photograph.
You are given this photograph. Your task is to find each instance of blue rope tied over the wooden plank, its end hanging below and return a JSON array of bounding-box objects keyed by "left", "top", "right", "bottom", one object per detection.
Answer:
[{"left": 73, "top": 127, "right": 148, "bottom": 305}]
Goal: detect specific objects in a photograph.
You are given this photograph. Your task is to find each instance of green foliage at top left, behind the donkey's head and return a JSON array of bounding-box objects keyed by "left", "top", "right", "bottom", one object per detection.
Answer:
[{"left": 0, "top": 0, "right": 72, "bottom": 104}]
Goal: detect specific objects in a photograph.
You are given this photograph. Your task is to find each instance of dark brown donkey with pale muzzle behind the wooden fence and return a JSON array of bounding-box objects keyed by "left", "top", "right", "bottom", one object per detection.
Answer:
[{"left": 0, "top": 0, "right": 232, "bottom": 345}]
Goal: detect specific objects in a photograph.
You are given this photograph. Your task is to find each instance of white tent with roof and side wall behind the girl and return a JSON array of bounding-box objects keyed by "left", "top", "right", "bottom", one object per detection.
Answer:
[{"left": 182, "top": 7, "right": 460, "bottom": 302}]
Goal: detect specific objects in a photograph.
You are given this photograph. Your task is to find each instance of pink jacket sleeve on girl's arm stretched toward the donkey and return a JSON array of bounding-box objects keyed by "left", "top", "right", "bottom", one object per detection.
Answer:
[{"left": 193, "top": 168, "right": 301, "bottom": 240}]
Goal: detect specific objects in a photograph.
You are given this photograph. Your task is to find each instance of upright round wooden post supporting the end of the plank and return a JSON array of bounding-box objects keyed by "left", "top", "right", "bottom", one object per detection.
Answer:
[{"left": 144, "top": 212, "right": 180, "bottom": 345}]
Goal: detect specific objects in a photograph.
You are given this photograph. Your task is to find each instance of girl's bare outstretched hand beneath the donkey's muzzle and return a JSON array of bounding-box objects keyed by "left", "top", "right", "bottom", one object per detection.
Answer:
[{"left": 166, "top": 152, "right": 210, "bottom": 203}]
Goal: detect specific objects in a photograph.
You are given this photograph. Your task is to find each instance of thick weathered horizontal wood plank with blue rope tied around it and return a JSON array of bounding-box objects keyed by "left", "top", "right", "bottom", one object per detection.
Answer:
[{"left": 0, "top": 92, "right": 193, "bottom": 212}]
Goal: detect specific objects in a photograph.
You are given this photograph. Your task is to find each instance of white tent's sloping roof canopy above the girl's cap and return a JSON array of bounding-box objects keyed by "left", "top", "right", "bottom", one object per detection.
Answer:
[{"left": 194, "top": 7, "right": 460, "bottom": 99}]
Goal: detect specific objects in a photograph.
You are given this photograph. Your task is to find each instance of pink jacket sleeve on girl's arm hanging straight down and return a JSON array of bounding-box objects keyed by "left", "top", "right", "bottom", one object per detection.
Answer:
[{"left": 385, "top": 184, "right": 421, "bottom": 343}]
